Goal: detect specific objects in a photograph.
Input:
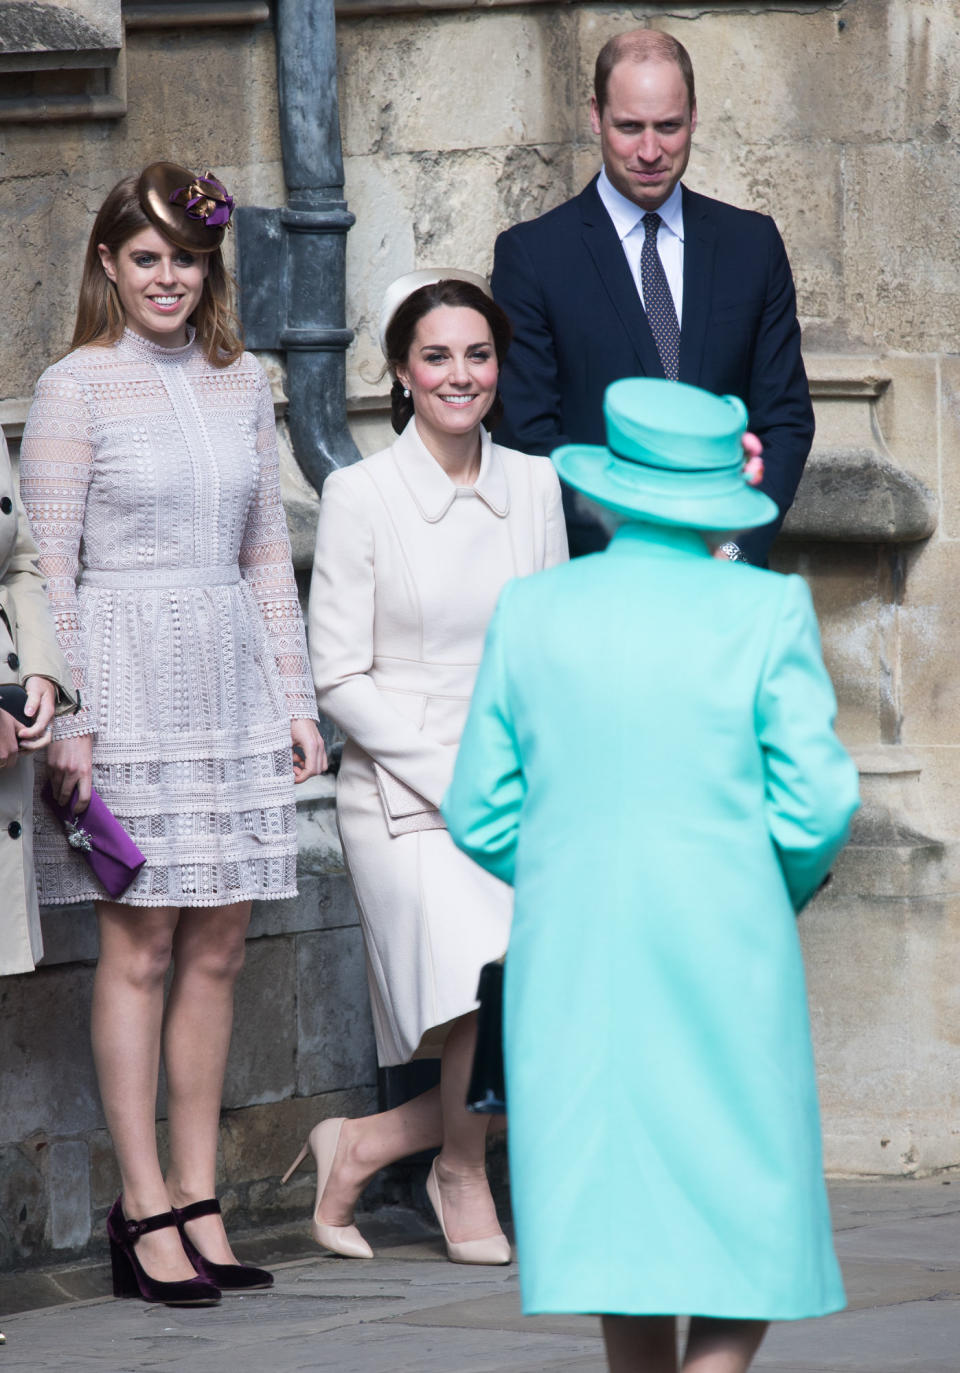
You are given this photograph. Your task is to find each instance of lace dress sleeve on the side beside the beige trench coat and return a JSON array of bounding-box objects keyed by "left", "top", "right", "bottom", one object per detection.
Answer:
[{"left": 21, "top": 359, "right": 96, "bottom": 739}]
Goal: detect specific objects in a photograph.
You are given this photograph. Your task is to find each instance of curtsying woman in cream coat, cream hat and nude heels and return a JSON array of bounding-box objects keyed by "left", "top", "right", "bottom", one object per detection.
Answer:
[{"left": 298, "top": 272, "right": 567, "bottom": 1263}]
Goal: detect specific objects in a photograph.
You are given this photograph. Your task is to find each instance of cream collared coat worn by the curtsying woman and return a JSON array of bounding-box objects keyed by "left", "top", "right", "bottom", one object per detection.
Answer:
[{"left": 309, "top": 420, "right": 567, "bottom": 1065}]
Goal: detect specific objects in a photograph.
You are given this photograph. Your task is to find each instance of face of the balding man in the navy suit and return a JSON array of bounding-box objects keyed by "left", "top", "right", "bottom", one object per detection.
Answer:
[{"left": 591, "top": 59, "right": 696, "bottom": 210}]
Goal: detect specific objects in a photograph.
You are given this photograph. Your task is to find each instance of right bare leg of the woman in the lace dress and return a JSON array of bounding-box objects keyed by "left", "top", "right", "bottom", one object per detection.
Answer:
[{"left": 163, "top": 901, "right": 250, "bottom": 1263}]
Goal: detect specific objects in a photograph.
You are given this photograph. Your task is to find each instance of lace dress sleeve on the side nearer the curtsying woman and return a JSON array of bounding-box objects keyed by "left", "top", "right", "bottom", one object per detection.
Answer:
[{"left": 240, "top": 371, "right": 317, "bottom": 719}]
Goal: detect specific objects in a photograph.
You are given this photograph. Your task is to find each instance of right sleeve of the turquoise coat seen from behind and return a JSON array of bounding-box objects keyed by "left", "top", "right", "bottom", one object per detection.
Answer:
[{"left": 755, "top": 577, "right": 860, "bottom": 912}]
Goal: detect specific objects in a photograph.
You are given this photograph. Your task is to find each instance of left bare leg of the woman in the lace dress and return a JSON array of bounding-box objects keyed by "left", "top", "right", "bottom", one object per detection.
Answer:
[{"left": 91, "top": 901, "right": 195, "bottom": 1282}]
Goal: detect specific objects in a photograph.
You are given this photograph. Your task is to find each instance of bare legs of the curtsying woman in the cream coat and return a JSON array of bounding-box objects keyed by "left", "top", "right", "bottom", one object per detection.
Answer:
[{"left": 310, "top": 1013, "right": 500, "bottom": 1243}]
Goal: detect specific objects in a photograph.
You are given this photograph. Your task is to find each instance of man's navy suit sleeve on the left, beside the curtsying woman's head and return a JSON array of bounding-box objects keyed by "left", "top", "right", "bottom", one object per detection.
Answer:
[{"left": 490, "top": 229, "right": 569, "bottom": 456}]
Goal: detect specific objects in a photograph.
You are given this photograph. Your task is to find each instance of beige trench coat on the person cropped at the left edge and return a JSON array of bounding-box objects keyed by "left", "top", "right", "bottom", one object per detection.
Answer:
[{"left": 0, "top": 431, "right": 76, "bottom": 975}]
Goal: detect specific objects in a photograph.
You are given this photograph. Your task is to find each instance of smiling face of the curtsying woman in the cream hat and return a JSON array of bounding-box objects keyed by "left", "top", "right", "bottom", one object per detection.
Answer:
[{"left": 397, "top": 305, "right": 499, "bottom": 448}]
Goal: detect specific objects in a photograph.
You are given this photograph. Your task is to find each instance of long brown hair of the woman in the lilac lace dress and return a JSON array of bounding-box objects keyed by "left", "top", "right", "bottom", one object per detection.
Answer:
[{"left": 70, "top": 173, "right": 243, "bottom": 367}]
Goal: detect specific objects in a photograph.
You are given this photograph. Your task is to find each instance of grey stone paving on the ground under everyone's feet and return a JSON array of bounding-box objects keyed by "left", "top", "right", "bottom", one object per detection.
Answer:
[{"left": 0, "top": 1178, "right": 960, "bottom": 1373}]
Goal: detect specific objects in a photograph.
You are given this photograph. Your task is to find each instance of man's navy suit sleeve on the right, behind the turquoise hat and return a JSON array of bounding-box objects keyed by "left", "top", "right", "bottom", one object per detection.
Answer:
[{"left": 739, "top": 218, "right": 814, "bottom": 564}]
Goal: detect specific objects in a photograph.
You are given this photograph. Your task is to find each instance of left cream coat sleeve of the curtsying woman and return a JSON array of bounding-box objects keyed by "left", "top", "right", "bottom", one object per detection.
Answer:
[{"left": 309, "top": 470, "right": 456, "bottom": 806}]
